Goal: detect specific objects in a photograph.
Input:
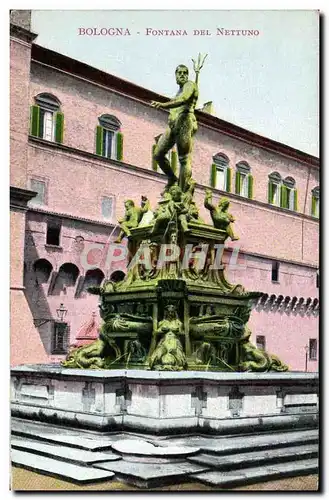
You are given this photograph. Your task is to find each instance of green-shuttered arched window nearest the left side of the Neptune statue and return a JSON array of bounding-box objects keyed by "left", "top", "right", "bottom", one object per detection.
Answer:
[{"left": 96, "top": 114, "right": 123, "bottom": 161}]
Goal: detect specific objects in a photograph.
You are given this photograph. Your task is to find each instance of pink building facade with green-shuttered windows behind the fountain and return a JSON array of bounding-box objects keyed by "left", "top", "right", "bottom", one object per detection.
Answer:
[{"left": 11, "top": 13, "right": 319, "bottom": 371}]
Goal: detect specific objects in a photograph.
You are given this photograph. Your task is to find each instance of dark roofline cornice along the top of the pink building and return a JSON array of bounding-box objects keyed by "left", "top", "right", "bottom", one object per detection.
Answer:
[{"left": 32, "top": 44, "right": 320, "bottom": 168}]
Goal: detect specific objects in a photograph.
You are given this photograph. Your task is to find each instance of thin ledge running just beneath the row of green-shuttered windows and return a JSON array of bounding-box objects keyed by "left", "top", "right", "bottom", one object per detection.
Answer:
[{"left": 29, "top": 135, "right": 319, "bottom": 224}]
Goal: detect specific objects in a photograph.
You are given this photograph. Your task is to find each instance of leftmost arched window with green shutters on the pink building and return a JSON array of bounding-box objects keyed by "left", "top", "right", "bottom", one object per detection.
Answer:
[{"left": 30, "top": 92, "right": 64, "bottom": 143}]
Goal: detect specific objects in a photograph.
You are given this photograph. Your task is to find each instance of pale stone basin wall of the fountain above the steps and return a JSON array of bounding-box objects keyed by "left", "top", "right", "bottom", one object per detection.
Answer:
[{"left": 11, "top": 365, "right": 318, "bottom": 435}]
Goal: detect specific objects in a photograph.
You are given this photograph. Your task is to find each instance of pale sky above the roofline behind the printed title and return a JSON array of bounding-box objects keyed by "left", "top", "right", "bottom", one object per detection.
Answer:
[{"left": 32, "top": 10, "right": 319, "bottom": 156}]
